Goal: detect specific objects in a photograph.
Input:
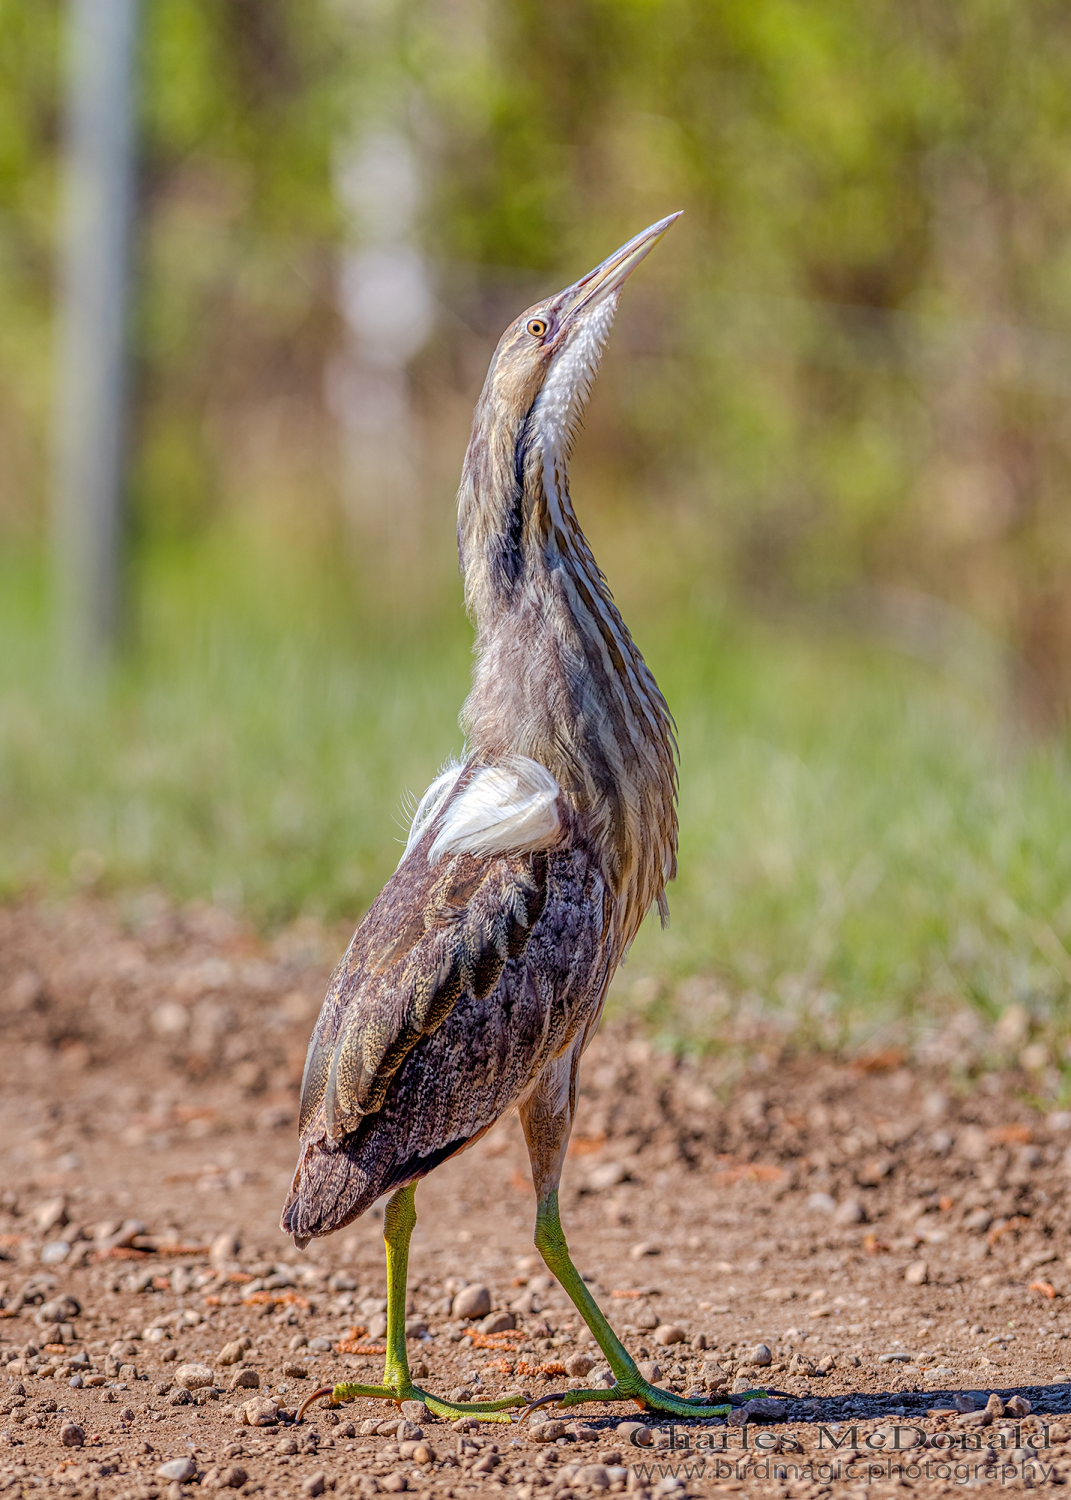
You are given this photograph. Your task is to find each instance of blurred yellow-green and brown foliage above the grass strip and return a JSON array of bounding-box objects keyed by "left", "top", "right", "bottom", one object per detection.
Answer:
[{"left": 0, "top": 0, "right": 1071, "bottom": 716}]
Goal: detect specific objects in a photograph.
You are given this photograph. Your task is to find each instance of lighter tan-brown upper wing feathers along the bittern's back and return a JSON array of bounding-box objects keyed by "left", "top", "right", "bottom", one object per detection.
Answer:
[{"left": 300, "top": 830, "right": 548, "bottom": 1140}]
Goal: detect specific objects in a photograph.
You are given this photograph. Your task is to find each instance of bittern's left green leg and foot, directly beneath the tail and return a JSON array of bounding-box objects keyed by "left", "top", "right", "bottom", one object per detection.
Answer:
[{"left": 299, "top": 1182, "right": 525, "bottom": 1422}]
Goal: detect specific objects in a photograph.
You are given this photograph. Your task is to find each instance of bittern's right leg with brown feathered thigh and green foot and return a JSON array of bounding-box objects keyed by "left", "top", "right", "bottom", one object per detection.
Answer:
[{"left": 521, "top": 1047, "right": 767, "bottom": 1418}]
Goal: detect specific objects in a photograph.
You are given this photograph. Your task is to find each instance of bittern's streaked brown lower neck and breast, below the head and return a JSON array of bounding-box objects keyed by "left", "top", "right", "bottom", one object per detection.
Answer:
[{"left": 459, "top": 434, "right": 677, "bottom": 945}]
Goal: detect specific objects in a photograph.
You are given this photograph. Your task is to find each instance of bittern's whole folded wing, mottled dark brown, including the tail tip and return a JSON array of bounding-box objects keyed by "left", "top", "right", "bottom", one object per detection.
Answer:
[{"left": 282, "top": 849, "right": 612, "bottom": 1242}]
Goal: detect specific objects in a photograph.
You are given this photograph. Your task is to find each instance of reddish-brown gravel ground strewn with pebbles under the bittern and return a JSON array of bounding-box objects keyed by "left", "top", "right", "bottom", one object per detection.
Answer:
[{"left": 0, "top": 897, "right": 1071, "bottom": 1500}]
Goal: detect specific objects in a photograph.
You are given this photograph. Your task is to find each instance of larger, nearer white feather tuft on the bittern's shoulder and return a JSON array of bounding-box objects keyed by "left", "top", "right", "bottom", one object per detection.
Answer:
[{"left": 426, "top": 756, "right": 561, "bottom": 864}]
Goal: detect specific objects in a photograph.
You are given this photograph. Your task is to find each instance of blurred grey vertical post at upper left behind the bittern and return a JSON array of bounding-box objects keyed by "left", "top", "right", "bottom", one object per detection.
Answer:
[{"left": 53, "top": 0, "right": 138, "bottom": 672}]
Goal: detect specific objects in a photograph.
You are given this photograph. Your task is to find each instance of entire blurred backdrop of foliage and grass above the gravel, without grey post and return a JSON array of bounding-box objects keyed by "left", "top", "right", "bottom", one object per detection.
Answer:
[{"left": 0, "top": 0, "right": 1071, "bottom": 1094}]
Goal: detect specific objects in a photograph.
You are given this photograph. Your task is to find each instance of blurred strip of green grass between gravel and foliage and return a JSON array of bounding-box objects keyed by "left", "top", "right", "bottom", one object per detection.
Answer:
[{"left": 0, "top": 539, "right": 1071, "bottom": 1068}]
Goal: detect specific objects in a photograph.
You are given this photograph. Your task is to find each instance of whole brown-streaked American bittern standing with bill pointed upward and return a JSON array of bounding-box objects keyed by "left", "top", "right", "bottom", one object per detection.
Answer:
[{"left": 282, "top": 215, "right": 759, "bottom": 1422}]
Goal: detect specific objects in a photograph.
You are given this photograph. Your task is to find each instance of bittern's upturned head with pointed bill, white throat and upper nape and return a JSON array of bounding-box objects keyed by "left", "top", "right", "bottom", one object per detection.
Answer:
[{"left": 458, "top": 213, "right": 680, "bottom": 614}]
